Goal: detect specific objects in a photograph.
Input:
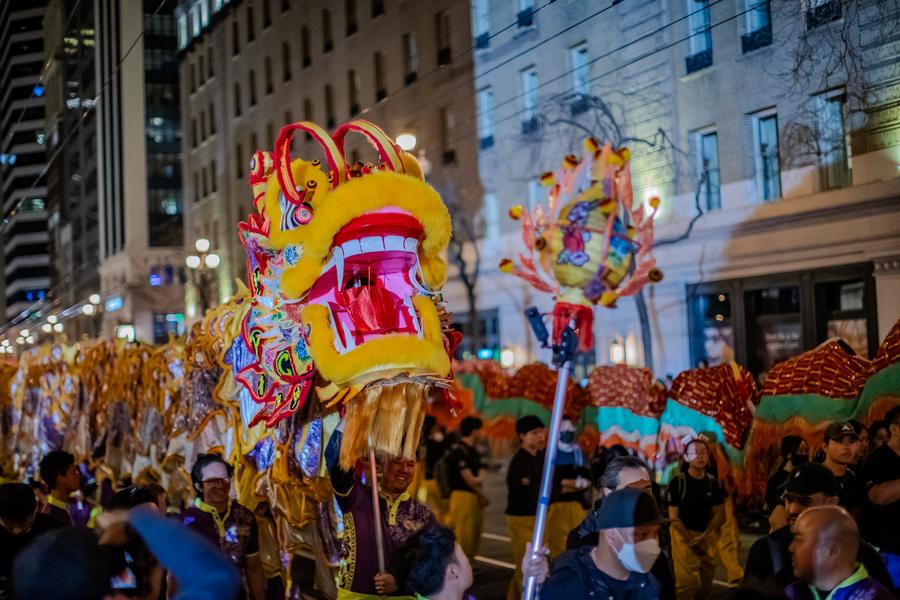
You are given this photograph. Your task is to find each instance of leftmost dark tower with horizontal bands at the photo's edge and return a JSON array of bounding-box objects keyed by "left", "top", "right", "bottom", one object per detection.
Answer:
[{"left": 0, "top": 0, "right": 50, "bottom": 323}]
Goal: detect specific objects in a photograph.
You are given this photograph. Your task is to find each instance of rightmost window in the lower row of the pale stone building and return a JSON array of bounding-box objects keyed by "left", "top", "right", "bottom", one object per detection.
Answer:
[{"left": 815, "top": 91, "right": 850, "bottom": 190}]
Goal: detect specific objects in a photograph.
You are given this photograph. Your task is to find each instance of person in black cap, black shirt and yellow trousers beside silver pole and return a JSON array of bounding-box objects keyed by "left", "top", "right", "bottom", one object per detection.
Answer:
[{"left": 506, "top": 415, "right": 547, "bottom": 600}]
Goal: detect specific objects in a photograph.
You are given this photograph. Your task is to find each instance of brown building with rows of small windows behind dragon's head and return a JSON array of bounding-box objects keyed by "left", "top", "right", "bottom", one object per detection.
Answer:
[{"left": 178, "top": 0, "right": 481, "bottom": 317}]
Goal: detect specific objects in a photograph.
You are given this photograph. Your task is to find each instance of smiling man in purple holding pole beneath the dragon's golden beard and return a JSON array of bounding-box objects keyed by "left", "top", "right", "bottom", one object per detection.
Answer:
[{"left": 325, "top": 422, "right": 437, "bottom": 600}]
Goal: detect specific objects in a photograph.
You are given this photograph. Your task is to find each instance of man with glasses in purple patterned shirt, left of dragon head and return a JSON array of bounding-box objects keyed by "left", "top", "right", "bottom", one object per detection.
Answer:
[{"left": 182, "top": 454, "right": 266, "bottom": 600}]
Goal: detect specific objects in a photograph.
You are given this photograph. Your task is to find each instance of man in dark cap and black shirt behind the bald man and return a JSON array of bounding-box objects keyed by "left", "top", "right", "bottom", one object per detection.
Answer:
[{"left": 744, "top": 463, "right": 894, "bottom": 591}]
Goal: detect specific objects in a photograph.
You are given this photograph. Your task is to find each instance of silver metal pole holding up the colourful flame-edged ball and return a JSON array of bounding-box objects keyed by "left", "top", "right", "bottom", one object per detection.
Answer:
[{"left": 517, "top": 307, "right": 577, "bottom": 600}]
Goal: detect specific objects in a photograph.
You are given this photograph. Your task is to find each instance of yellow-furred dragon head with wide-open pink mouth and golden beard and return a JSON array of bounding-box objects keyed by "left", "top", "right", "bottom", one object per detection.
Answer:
[{"left": 238, "top": 120, "right": 454, "bottom": 466}]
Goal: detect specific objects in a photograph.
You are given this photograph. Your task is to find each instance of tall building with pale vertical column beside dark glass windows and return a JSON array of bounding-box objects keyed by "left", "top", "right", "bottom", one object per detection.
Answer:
[{"left": 94, "top": 0, "right": 184, "bottom": 342}]
